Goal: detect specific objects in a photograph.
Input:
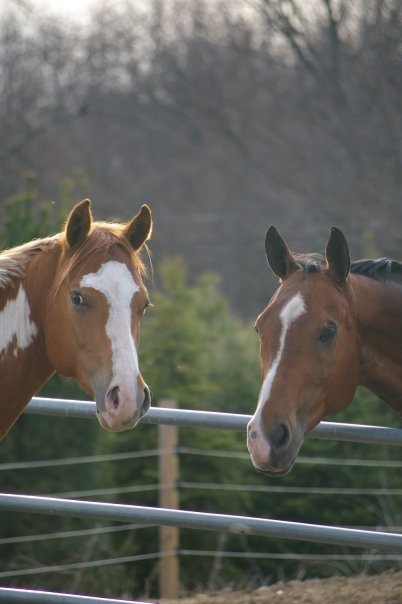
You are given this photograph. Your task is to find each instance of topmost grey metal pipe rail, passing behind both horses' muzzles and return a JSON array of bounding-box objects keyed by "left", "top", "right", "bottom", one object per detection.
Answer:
[{"left": 25, "top": 397, "right": 402, "bottom": 447}]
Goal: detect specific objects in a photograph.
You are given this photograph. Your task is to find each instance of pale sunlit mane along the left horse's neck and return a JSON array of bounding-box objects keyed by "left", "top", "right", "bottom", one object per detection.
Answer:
[{"left": 0, "top": 237, "right": 56, "bottom": 289}]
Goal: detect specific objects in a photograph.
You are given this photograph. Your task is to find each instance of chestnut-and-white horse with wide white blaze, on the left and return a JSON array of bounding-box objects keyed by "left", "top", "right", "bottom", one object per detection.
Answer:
[{"left": 0, "top": 199, "right": 152, "bottom": 437}]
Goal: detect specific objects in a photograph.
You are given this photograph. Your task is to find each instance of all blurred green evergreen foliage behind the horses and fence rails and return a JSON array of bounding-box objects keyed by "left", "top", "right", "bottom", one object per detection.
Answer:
[{"left": 0, "top": 188, "right": 402, "bottom": 597}]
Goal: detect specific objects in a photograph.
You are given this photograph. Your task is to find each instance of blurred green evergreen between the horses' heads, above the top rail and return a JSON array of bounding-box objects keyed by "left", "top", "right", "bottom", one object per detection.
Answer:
[{"left": 141, "top": 258, "right": 259, "bottom": 411}]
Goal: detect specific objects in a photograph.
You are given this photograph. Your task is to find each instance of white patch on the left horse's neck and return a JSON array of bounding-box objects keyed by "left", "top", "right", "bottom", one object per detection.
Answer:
[{"left": 0, "top": 285, "right": 38, "bottom": 357}]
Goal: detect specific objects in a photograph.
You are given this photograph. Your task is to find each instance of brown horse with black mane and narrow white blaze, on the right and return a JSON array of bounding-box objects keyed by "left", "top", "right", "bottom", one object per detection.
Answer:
[{"left": 247, "top": 227, "right": 402, "bottom": 476}]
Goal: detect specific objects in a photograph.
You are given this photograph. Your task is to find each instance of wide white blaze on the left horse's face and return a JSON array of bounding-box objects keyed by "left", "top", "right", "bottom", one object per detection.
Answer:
[{"left": 80, "top": 260, "right": 140, "bottom": 388}]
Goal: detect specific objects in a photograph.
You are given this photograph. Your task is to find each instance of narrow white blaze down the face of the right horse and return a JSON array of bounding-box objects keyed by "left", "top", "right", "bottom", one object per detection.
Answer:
[{"left": 248, "top": 293, "right": 306, "bottom": 459}]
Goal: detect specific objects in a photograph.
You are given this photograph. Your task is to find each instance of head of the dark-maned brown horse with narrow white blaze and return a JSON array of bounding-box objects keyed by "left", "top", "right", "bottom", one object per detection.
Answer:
[{"left": 248, "top": 227, "right": 358, "bottom": 476}]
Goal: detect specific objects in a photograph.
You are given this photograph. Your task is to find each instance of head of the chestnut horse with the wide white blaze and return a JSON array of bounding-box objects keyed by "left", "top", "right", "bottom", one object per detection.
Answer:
[{"left": 45, "top": 200, "right": 152, "bottom": 431}]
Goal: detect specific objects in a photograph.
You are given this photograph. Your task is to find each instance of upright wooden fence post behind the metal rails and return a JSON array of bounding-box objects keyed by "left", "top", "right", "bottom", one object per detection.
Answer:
[{"left": 159, "top": 399, "right": 179, "bottom": 598}]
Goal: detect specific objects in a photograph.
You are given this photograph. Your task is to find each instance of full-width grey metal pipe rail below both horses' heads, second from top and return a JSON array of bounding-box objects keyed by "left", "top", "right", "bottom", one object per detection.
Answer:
[{"left": 0, "top": 493, "right": 402, "bottom": 552}]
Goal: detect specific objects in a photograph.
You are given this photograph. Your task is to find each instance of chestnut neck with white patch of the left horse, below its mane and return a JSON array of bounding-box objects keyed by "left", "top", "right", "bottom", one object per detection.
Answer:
[{"left": 0, "top": 251, "right": 57, "bottom": 438}]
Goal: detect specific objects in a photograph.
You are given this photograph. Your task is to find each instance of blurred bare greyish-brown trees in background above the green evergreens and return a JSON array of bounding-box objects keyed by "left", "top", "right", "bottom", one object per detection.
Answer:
[{"left": 0, "top": 0, "right": 402, "bottom": 318}]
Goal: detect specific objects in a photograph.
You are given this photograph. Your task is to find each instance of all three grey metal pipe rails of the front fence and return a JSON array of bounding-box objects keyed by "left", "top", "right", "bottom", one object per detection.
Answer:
[{"left": 0, "top": 398, "right": 402, "bottom": 604}]
